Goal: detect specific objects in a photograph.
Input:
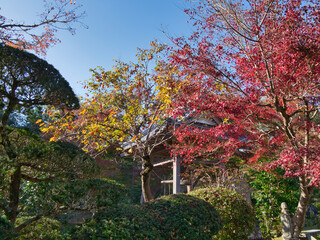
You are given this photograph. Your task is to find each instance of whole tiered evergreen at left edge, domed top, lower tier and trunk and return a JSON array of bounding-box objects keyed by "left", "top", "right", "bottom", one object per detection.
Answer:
[{"left": 0, "top": 43, "right": 84, "bottom": 231}]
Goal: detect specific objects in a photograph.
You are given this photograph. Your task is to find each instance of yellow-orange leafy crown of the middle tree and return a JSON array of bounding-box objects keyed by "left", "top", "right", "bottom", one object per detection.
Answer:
[{"left": 42, "top": 42, "right": 180, "bottom": 157}]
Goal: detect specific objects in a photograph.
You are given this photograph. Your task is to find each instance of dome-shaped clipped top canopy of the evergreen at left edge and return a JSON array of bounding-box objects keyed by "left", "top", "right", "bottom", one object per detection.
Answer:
[{"left": 0, "top": 44, "right": 79, "bottom": 109}]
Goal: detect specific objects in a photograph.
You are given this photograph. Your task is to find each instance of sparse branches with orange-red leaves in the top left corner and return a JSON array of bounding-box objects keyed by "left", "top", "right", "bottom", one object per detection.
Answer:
[{"left": 0, "top": 0, "right": 84, "bottom": 54}]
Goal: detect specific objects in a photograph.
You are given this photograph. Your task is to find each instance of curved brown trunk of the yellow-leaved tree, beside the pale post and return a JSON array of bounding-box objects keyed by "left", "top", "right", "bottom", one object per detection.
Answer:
[{"left": 140, "top": 156, "right": 153, "bottom": 202}]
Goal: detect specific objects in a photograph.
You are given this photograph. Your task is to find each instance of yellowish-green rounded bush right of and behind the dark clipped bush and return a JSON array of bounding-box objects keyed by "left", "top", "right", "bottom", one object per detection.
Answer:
[{"left": 190, "top": 188, "right": 255, "bottom": 240}]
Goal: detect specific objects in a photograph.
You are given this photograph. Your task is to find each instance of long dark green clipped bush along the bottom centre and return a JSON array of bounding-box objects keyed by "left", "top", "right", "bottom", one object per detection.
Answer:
[{"left": 73, "top": 194, "right": 221, "bottom": 240}]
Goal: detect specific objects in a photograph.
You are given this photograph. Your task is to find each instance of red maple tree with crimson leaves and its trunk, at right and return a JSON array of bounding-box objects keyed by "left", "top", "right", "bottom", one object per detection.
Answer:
[{"left": 171, "top": 0, "right": 320, "bottom": 236}]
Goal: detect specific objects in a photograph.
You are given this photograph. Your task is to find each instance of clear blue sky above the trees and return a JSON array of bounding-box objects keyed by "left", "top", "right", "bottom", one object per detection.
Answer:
[{"left": 0, "top": 0, "right": 192, "bottom": 95}]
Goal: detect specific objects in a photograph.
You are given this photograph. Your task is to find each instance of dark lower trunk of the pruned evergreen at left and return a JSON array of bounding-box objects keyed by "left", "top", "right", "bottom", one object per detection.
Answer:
[{"left": 7, "top": 166, "right": 21, "bottom": 224}]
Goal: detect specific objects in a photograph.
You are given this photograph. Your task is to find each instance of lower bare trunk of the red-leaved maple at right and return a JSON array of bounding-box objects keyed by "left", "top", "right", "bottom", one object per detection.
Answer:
[{"left": 293, "top": 179, "right": 314, "bottom": 240}]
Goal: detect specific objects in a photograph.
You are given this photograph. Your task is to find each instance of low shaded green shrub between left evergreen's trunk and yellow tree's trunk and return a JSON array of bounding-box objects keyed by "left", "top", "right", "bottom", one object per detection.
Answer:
[{"left": 21, "top": 178, "right": 127, "bottom": 218}]
